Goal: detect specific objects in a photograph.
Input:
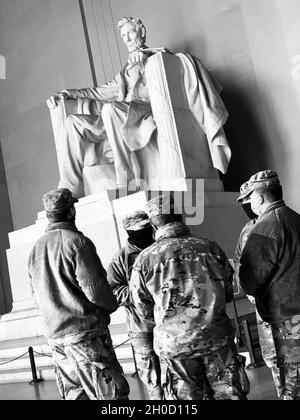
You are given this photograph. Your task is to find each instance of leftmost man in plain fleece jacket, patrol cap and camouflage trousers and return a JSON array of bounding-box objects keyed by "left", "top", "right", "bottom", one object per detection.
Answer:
[{"left": 28, "top": 188, "right": 129, "bottom": 400}]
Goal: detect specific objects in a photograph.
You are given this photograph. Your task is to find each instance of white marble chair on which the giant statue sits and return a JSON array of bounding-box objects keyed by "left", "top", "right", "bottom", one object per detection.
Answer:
[{"left": 50, "top": 52, "right": 223, "bottom": 195}]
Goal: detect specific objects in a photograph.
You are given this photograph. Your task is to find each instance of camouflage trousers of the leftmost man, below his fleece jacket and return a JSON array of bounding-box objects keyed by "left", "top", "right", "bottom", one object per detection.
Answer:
[{"left": 49, "top": 331, "right": 129, "bottom": 400}]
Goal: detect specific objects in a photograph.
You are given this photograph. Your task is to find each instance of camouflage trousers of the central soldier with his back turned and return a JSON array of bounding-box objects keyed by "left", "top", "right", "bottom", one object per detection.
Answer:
[{"left": 160, "top": 343, "right": 250, "bottom": 400}]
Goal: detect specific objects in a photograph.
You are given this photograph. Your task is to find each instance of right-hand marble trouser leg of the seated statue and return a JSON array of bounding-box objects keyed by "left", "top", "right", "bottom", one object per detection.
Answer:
[{"left": 102, "top": 102, "right": 139, "bottom": 187}]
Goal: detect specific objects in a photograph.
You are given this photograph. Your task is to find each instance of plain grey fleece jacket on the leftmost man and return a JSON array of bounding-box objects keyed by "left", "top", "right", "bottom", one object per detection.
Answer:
[{"left": 28, "top": 222, "right": 117, "bottom": 339}]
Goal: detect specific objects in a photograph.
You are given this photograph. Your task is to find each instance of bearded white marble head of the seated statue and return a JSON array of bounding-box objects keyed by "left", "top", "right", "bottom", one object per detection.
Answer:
[{"left": 118, "top": 17, "right": 146, "bottom": 53}]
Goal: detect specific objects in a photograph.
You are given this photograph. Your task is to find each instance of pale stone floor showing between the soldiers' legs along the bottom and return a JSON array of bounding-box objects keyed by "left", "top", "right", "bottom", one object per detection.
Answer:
[{"left": 0, "top": 366, "right": 277, "bottom": 400}]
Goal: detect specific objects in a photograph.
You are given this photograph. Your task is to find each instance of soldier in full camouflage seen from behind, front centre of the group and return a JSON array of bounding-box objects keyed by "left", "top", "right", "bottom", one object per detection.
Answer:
[{"left": 130, "top": 194, "right": 249, "bottom": 400}]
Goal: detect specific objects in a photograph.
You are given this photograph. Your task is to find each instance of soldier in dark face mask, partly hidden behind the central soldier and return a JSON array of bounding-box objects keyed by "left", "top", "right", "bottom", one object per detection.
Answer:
[{"left": 107, "top": 210, "right": 161, "bottom": 400}]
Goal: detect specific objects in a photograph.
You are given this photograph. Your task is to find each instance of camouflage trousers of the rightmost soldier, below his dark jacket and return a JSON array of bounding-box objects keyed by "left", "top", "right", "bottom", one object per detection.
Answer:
[{"left": 256, "top": 313, "right": 300, "bottom": 400}]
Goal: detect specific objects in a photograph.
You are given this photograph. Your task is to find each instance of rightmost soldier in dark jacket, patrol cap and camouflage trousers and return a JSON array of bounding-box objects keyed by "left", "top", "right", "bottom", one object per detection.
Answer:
[{"left": 239, "top": 170, "right": 300, "bottom": 400}]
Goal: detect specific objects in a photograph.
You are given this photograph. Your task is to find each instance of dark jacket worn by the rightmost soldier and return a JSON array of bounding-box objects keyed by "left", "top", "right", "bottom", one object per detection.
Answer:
[{"left": 240, "top": 201, "right": 300, "bottom": 324}]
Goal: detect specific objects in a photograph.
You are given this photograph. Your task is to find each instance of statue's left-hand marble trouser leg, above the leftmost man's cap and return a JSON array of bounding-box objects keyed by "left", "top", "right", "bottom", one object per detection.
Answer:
[{"left": 59, "top": 115, "right": 105, "bottom": 197}]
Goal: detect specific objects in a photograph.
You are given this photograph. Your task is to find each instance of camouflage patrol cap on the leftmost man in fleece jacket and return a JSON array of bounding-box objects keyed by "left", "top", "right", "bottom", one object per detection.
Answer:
[{"left": 43, "top": 188, "right": 78, "bottom": 214}]
